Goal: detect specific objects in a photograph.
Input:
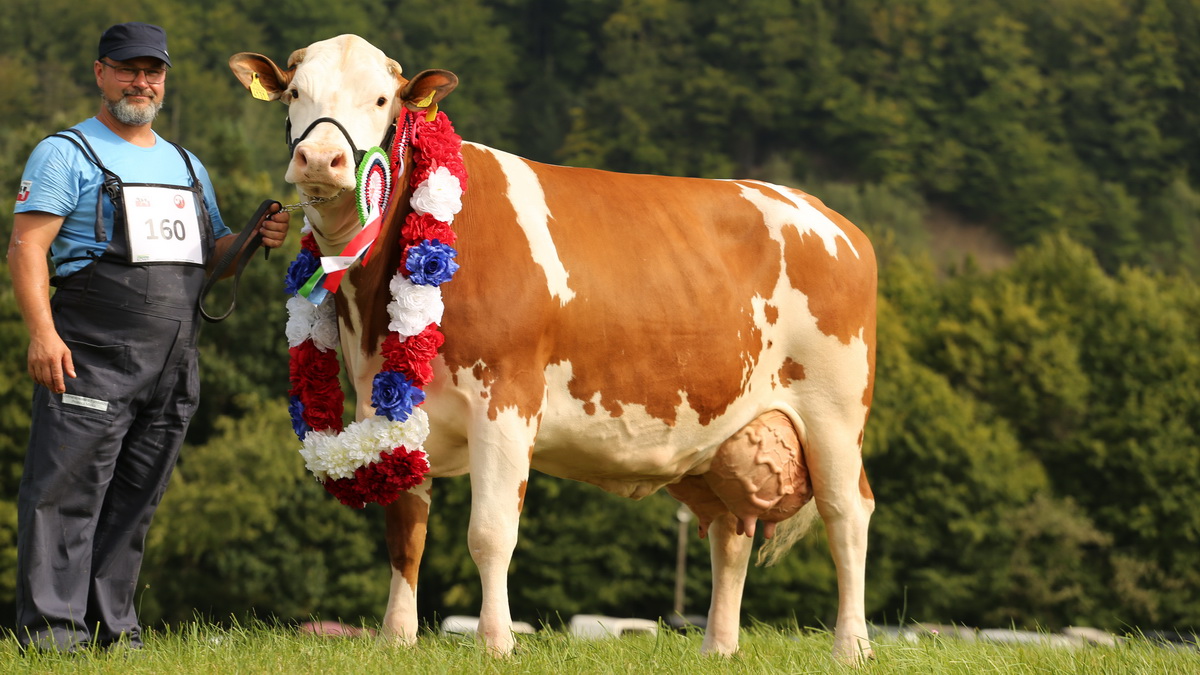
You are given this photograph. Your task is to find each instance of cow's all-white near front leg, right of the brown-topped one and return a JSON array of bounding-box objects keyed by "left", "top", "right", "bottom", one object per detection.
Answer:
[{"left": 467, "top": 411, "right": 536, "bottom": 656}]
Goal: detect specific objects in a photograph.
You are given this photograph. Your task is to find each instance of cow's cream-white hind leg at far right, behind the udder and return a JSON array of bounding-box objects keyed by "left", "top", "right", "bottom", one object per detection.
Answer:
[{"left": 805, "top": 424, "right": 875, "bottom": 663}]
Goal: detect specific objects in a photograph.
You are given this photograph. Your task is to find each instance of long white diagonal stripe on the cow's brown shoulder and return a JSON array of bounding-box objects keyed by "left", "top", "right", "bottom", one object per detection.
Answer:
[{"left": 472, "top": 143, "right": 575, "bottom": 306}]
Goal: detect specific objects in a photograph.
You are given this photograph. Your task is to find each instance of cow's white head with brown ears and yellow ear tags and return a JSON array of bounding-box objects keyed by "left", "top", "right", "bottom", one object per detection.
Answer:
[{"left": 229, "top": 35, "right": 458, "bottom": 211}]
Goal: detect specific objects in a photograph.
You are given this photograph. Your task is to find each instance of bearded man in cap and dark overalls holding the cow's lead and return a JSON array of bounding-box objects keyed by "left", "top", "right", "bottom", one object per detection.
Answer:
[{"left": 8, "top": 23, "right": 288, "bottom": 651}]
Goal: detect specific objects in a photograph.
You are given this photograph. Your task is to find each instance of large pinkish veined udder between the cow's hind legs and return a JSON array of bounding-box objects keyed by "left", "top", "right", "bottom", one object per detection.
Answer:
[{"left": 667, "top": 411, "right": 812, "bottom": 539}]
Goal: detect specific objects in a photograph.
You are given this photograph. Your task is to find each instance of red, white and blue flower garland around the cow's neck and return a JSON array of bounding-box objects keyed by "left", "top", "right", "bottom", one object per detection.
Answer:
[{"left": 284, "top": 110, "right": 467, "bottom": 508}]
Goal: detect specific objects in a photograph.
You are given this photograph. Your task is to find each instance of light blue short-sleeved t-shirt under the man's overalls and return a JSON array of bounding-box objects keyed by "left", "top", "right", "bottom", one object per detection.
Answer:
[{"left": 13, "top": 118, "right": 229, "bottom": 276}]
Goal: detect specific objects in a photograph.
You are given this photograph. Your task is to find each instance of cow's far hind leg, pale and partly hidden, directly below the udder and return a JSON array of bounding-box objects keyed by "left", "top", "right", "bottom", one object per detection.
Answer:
[{"left": 700, "top": 512, "right": 754, "bottom": 656}]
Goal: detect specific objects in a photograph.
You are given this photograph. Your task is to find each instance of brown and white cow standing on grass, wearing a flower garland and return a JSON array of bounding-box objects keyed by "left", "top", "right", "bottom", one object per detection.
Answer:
[{"left": 229, "top": 35, "right": 877, "bottom": 663}]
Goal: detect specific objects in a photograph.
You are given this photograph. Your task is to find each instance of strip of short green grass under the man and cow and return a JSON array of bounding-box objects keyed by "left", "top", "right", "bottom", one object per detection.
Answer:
[{"left": 0, "top": 623, "right": 1200, "bottom": 675}]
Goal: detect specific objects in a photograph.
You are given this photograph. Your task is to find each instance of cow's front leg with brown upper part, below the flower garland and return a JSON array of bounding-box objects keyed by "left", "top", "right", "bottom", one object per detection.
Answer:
[{"left": 383, "top": 477, "right": 433, "bottom": 645}]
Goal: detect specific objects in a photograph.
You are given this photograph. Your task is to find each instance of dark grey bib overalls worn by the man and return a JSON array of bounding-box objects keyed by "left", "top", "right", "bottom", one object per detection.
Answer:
[{"left": 17, "top": 130, "right": 214, "bottom": 650}]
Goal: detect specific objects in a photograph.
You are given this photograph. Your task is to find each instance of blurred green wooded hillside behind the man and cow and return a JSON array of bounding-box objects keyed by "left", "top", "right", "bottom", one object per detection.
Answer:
[{"left": 0, "top": 0, "right": 1200, "bottom": 629}]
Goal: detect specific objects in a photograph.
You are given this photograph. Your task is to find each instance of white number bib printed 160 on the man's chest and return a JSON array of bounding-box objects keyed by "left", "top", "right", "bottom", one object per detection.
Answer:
[{"left": 124, "top": 185, "right": 204, "bottom": 265}]
